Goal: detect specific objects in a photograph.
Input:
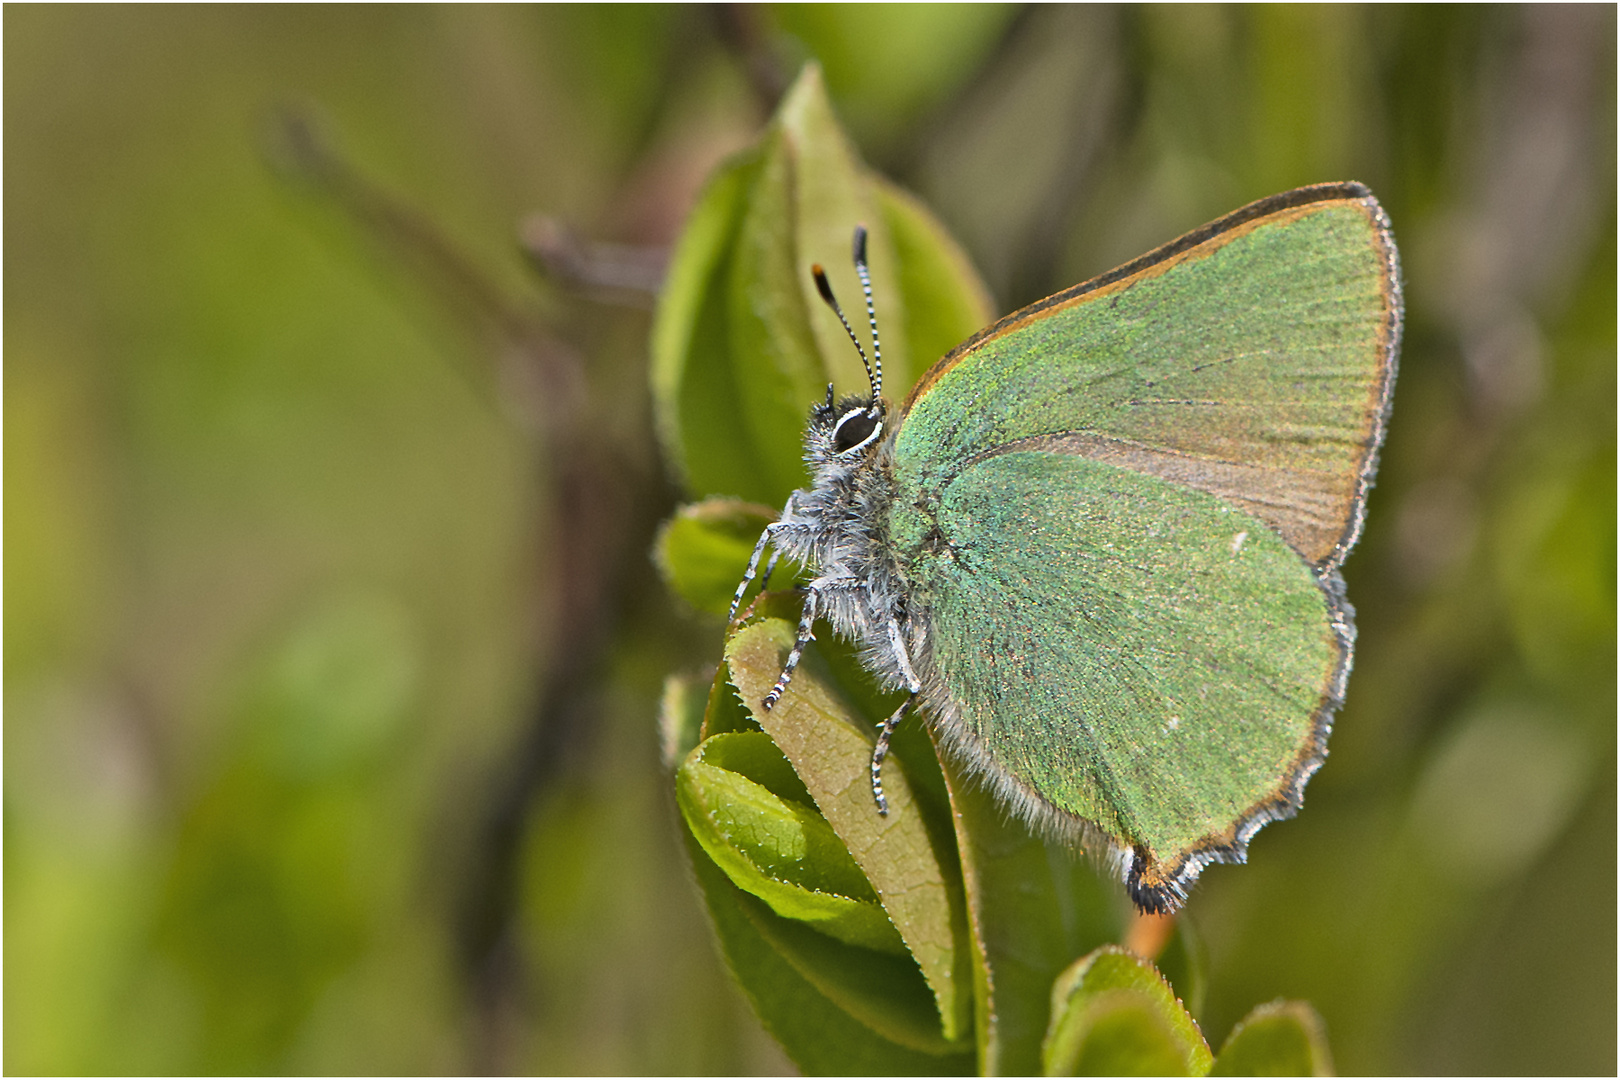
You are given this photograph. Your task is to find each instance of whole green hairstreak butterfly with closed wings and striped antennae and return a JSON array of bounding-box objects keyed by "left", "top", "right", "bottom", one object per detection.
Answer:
[{"left": 732, "top": 183, "right": 1401, "bottom": 912}]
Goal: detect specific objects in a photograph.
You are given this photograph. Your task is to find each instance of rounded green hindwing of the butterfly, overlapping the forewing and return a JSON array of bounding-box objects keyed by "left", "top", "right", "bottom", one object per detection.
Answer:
[{"left": 914, "top": 452, "right": 1348, "bottom": 906}]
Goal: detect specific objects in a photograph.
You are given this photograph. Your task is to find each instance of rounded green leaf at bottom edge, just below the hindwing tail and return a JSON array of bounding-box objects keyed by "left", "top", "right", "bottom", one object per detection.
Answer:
[{"left": 1042, "top": 946, "right": 1210, "bottom": 1077}]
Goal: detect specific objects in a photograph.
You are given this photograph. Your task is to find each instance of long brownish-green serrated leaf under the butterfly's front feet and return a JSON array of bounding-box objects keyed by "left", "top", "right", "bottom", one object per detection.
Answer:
[{"left": 726, "top": 619, "right": 972, "bottom": 1043}]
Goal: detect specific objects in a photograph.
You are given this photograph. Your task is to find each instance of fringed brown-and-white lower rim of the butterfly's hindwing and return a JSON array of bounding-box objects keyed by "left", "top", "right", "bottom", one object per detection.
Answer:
[{"left": 912, "top": 570, "right": 1356, "bottom": 915}]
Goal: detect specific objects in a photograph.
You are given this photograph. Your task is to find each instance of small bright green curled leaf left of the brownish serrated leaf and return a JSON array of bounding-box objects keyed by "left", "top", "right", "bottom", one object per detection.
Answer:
[{"left": 676, "top": 732, "right": 904, "bottom": 954}]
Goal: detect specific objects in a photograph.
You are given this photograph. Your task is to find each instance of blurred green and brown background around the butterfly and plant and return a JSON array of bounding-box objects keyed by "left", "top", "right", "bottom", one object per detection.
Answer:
[{"left": 3, "top": 6, "right": 1617, "bottom": 1074}]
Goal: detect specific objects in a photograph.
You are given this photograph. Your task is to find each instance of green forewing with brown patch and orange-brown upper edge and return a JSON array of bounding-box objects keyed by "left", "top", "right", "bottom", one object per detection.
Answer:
[{"left": 894, "top": 185, "right": 1400, "bottom": 567}]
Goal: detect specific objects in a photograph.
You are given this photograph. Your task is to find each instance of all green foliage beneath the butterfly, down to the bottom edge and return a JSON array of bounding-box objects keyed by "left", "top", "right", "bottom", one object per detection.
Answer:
[{"left": 676, "top": 608, "right": 1330, "bottom": 1075}]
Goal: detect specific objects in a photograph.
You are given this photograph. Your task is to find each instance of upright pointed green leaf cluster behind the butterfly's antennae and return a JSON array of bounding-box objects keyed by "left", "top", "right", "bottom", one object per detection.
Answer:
[{"left": 651, "top": 65, "right": 990, "bottom": 511}]
